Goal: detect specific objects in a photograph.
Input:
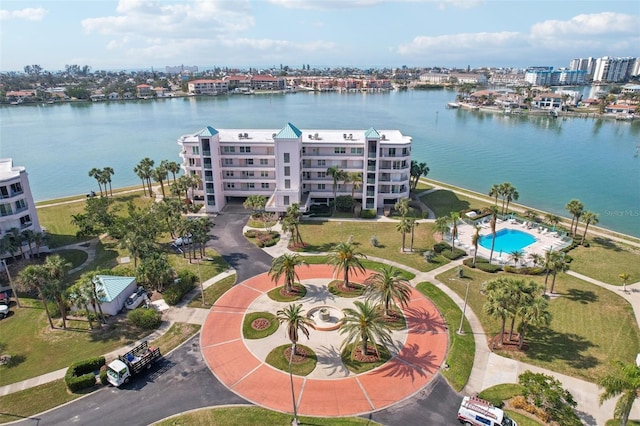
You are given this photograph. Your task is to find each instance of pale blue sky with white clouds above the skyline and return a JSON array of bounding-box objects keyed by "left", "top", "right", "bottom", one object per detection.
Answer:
[{"left": 0, "top": 0, "right": 640, "bottom": 71}]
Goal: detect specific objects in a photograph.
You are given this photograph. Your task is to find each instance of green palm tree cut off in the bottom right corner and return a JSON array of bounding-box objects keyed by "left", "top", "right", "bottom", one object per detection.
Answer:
[{"left": 599, "top": 362, "right": 640, "bottom": 426}]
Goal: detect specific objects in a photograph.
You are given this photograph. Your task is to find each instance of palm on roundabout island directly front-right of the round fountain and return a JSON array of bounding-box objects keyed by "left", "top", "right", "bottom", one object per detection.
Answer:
[{"left": 340, "top": 300, "right": 394, "bottom": 358}]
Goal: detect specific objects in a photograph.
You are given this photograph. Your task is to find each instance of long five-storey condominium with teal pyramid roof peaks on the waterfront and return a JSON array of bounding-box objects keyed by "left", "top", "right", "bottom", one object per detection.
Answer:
[{"left": 178, "top": 123, "right": 411, "bottom": 212}]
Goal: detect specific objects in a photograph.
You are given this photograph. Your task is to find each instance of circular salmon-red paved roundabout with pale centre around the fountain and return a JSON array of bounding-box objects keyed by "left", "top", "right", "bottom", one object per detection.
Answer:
[{"left": 200, "top": 265, "right": 448, "bottom": 417}]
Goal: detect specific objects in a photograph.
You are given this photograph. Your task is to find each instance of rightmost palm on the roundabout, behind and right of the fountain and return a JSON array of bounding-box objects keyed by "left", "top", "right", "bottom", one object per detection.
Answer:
[{"left": 365, "top": 266, "right": 411, "bottom": 317}]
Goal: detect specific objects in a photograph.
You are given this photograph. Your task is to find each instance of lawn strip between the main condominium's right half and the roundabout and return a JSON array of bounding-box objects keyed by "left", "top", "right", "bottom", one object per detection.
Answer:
[{"left": 300, "top": 220, "right": 442, "bottom": 271}]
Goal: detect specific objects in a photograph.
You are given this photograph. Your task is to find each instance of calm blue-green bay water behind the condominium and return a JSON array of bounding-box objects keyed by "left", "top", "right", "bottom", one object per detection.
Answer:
[{"left": 0, "top": 90, "right": 640, "bottom": 236}]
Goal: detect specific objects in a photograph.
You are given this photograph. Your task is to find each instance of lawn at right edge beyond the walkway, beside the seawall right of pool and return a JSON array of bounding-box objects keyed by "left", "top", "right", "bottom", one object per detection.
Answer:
[{"left": 569, "top": 238, "right": 640, "bottom": 286}]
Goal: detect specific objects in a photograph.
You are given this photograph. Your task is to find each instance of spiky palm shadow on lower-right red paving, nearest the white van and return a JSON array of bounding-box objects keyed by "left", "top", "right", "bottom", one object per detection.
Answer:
[{"left": 373, "top": 344, "right": 440, "bottom": 381}]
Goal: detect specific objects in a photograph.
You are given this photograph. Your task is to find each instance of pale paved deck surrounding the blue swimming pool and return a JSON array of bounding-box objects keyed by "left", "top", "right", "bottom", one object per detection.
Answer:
[{"left": 456, "top": 219, "right": 569, "bottom": 266}]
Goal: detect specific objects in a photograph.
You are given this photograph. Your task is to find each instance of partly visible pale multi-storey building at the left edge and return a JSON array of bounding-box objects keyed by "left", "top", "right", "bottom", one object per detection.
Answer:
[{"left": 0, "top": 158, "right": 42, "bottom": 259}]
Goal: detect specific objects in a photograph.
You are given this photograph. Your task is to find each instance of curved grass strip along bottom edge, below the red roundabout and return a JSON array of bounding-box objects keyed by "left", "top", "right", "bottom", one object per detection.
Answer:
[{"left": 154, "top": 406, "right": 379, "bottom": 426}]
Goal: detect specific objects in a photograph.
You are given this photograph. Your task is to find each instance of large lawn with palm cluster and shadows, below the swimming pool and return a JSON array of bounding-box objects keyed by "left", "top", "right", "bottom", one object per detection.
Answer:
[{"left": 437, "top": 268, "right": 640, "bottom": 382}]
